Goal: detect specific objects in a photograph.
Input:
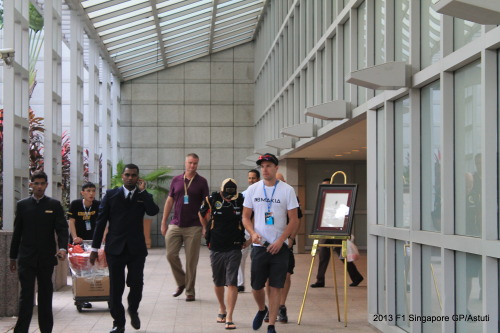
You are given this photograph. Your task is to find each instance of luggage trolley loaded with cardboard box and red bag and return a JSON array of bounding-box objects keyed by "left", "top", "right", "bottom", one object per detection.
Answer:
[{"left": 68, "top": 240, "right": 110, "bottom": 312}]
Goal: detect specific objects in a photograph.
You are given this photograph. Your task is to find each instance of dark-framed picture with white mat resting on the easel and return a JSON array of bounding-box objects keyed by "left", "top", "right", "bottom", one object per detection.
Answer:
[{"left": 311, "top": 184, "right": 358, "bottom": 236}]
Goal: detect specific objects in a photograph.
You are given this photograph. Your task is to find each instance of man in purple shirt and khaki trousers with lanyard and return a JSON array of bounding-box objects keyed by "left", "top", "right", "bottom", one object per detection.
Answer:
[{"left": 161, "top": 153, "right": 209, "bottom": 302}]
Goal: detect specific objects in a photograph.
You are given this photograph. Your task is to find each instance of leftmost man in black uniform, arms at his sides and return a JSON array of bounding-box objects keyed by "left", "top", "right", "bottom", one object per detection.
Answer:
[{"left": 10, "top": 171, "right": 68, "bottom": 333}]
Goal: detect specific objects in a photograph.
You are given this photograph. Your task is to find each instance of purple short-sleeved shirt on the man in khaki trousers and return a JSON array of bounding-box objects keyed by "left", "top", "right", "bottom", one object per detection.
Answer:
[{"left": 168, "top": 174, "right": 208, "bottom": 228}]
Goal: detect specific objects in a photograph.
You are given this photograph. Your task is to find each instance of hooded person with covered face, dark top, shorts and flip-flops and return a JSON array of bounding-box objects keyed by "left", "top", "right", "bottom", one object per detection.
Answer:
[{"left": 199, "top": 178, "right": 245, "bottom": 329}]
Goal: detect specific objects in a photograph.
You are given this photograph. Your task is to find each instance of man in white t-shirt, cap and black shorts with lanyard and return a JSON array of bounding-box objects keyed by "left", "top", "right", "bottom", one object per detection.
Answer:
[{"left": 243, "top": 154, "right": 299, "bottom": 333}]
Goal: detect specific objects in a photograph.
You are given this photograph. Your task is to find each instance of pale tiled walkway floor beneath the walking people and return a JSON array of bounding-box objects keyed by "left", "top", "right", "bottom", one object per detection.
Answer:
[{"left": 0, "top": 247, "right": 378, "bottom": 333}]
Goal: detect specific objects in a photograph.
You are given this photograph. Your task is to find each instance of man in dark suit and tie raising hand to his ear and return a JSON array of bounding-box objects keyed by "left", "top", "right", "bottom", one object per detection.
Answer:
[{"left": 90, "top": 164, "right": 160, "bottom": 333}]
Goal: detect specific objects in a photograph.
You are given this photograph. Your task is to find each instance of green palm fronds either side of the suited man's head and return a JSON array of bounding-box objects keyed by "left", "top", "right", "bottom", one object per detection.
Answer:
[{"left": 110, "top": 160, "right": 172, "bottom": 202}]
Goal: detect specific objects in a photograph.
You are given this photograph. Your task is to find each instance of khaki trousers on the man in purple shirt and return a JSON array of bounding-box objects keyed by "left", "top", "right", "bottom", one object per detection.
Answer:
[{"left": 165, "top": 225, "right": 201, "bottom": 296}]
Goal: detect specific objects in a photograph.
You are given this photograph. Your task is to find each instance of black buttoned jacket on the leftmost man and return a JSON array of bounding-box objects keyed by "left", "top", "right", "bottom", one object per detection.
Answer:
[{"left": 10, "top": 196, "right": 68, "bottom": 267}]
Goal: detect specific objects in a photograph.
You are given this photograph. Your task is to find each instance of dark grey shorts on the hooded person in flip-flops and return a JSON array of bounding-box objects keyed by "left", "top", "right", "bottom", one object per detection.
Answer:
[{"left": 210, "top": 249, "right": 241, "bottom": 287}]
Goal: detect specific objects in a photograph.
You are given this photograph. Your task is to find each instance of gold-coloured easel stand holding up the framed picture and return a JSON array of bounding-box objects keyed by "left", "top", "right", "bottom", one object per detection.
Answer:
[{"left": 297, "top": 171, "right": 351, "bottom": 327}]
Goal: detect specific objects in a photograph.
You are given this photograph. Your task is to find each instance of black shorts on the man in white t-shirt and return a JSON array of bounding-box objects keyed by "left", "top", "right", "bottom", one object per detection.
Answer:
[{"left": 250, "top": 245, "right": 290, "bottom": 290}]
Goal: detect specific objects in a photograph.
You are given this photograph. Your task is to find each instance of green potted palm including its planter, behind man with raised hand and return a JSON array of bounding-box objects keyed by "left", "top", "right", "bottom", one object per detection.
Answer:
[{"left": 109, "top": 160, "right": 172, "bottom": 248}]
